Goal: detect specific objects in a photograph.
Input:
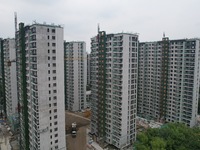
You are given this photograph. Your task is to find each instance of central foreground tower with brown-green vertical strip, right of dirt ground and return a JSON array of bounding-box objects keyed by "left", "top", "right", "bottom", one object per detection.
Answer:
[{"left": 91, "top": 31, "right": 138, "bottom": 148}]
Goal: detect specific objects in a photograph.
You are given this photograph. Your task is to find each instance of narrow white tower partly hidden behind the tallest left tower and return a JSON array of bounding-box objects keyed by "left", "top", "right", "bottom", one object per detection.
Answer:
[{"left": 3, "top": 39, "right": 18, "bottom": 119}]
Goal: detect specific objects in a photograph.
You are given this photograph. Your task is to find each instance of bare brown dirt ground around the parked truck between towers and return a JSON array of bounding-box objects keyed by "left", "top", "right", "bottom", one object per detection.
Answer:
[{"left": 65, "top": 111, "right": 90, "bottom": 150}]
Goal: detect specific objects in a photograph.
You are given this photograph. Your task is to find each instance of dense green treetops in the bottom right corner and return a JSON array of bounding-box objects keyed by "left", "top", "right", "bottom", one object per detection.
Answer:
[{"left": 134, "top": 123, "right": 200, "bottom": 150}]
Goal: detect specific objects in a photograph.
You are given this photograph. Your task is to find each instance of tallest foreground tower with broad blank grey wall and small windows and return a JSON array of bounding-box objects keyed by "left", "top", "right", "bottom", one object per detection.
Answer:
[{"left": 16, "top": 23, "right": 66, "bottom": 150}]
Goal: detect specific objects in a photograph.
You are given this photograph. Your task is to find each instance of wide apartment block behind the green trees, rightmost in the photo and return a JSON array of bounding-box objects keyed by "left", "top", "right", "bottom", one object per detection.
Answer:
[{"left": 137, "top": 37, "right": 200, "bottom": 127}]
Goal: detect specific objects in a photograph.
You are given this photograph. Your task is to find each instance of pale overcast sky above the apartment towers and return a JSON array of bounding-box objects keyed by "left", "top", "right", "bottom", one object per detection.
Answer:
[{"left": 0, "top": 0, "right": 200, "bottom": 51}]
